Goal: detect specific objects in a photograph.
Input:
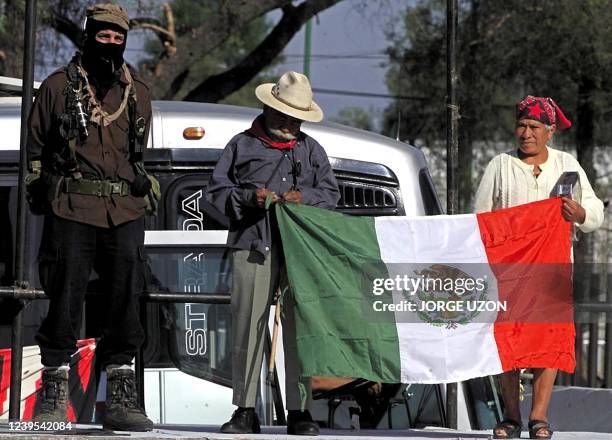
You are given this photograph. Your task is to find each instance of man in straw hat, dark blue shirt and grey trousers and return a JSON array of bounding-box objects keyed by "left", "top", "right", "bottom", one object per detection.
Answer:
[{"left": 206, "top": 72, "right": 339, "bottom": 435}]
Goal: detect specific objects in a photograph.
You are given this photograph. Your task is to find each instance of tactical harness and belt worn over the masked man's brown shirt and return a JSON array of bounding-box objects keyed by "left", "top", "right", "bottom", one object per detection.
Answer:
[{"left": 26, "top": 53, "right": 160, "bottom": 218}]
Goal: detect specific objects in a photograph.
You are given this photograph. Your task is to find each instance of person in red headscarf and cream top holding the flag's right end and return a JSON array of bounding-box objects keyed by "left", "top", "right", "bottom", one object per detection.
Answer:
[{"left": 474, "top": 95, "right": 603, "bottom": 438}]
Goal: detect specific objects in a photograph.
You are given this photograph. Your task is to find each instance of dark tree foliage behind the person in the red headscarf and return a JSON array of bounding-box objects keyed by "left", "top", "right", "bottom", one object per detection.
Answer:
[{"left": 383, "top": 0, "right": 612, "bottom": 211}]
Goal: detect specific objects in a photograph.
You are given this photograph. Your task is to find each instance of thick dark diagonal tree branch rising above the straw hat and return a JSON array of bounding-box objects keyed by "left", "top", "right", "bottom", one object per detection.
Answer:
[{"left": 185, "top": 0, "right": 341, "bottom": 102}]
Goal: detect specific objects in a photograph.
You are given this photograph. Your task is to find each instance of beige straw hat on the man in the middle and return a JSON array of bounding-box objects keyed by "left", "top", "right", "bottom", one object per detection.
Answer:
[{"left": 255, "top": 71, "right": 323, "bottom": 122}]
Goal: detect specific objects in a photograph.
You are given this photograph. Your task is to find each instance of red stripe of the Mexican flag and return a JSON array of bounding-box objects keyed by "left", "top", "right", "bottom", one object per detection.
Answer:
[{"left": 477, "top": 198, "right": 576, "bottom": 372}]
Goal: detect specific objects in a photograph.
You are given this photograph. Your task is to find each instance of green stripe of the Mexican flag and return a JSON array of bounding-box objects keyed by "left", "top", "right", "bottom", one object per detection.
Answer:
[{"left": 276, "top": 203, "right": 400, "bottom": 383}]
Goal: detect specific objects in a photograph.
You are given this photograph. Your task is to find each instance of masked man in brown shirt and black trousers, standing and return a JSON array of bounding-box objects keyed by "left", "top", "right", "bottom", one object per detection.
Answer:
[{"left": 28, "top": 4, "right": 153, "bottom": 431}]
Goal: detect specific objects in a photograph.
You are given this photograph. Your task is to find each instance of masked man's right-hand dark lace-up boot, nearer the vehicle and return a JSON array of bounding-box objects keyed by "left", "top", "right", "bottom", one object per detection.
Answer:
[{"left": 102, "top": 368, "right": 153, "bottom": 431}]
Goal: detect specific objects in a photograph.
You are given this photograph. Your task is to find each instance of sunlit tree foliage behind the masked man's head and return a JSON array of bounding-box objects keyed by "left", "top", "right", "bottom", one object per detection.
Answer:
[{"left": 0, "top": 0, "right": 341, "bottom": 105}]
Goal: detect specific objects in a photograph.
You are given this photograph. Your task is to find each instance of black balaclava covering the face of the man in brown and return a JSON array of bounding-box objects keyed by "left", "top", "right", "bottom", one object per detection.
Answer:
[{"left": 82, "top": 18, "right": 127, "bottom": 100}]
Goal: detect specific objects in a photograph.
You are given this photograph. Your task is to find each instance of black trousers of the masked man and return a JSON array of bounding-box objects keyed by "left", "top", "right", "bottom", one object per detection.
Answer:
[{"left": 36, "top": 215, "right": 145, "bottom": 367}]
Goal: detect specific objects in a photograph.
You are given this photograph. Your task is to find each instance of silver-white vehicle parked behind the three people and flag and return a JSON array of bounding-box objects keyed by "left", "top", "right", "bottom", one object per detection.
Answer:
[{"left": 0, "top": 75, "right": 499, "bottom": 429}]
